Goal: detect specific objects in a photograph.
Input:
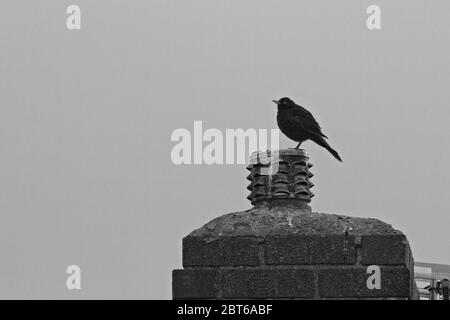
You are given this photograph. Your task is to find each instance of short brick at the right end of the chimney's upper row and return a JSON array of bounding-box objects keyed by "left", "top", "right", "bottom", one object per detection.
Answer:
[{"left": 361, "top": 234, "right": 410, "bottom": 267}]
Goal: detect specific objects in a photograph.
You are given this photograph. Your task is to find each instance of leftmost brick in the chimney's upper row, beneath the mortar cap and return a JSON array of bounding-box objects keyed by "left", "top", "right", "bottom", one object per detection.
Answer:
[{"left": 183, "top": 236, "right": 259, "bottom": 267}]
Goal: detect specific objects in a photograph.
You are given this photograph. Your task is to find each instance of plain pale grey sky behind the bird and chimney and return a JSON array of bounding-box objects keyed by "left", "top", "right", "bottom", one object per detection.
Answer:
[{"left": 0, "top": 0, "right": 450, "bottom": 299}]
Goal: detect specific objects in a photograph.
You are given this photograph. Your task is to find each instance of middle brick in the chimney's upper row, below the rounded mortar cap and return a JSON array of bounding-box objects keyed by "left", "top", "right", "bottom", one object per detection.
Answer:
[{"left": 264, "top": 235, "right": 356, "bottom": 265}]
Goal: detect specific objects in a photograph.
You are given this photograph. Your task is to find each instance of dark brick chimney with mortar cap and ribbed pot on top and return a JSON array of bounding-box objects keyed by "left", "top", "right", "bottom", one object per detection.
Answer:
[{"left": 172, "top": 149, "right": 418, "bottom": 299}]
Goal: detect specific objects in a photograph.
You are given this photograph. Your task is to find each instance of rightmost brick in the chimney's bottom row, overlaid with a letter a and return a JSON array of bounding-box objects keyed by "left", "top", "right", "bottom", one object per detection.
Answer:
[{"left": 318, "top": 266, "right": 411, "bottom": 298}]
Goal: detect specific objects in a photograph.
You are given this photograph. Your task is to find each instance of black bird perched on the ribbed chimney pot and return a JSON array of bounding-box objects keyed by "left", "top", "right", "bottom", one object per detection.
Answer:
[{"left": 272, "top": 97, "right": 342, "bottom": 162}]
